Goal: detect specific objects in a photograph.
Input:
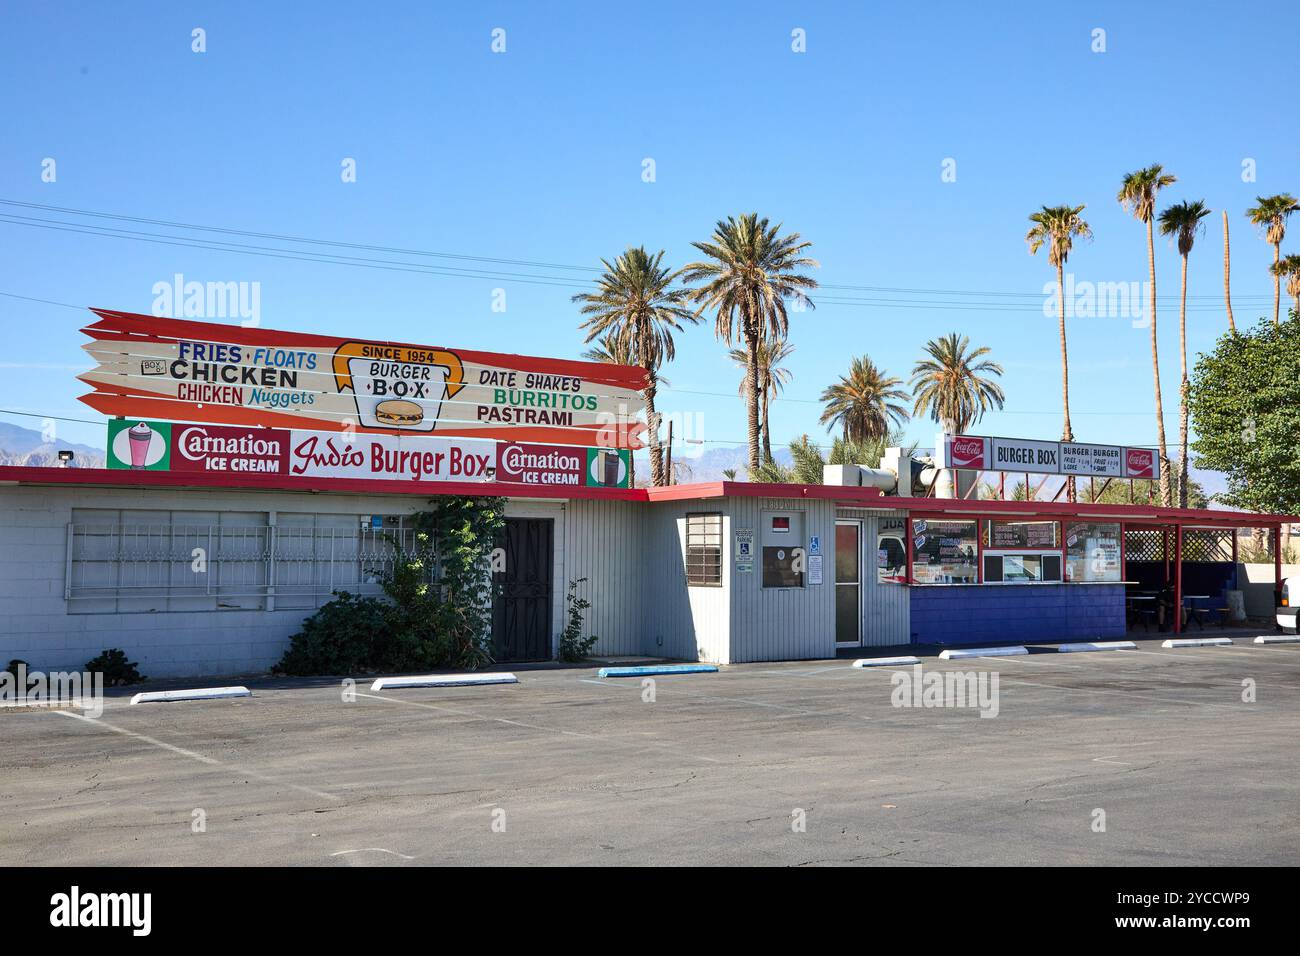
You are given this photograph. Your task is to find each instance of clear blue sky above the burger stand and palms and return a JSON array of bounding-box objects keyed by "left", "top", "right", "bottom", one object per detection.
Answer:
[{"left": 0, "top": 1, "right": 1300, "bottom": 463}]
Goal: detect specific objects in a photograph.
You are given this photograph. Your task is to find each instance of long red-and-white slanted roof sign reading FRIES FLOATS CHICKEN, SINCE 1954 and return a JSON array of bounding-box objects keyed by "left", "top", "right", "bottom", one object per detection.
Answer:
[{"left": 79, "top": 308, "right": 646, "bottom": 449}]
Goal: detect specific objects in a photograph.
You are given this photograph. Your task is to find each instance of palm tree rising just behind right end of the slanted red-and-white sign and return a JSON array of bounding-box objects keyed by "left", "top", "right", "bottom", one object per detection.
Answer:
[{"left": 573, "top": 246, "right": 698, "bottom": 485}]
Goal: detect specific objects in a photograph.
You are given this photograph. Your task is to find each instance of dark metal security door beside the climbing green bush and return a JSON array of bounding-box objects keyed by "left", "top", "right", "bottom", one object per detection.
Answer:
[{"left": 491, "top": 518, "right": 555, "bottom": 661}]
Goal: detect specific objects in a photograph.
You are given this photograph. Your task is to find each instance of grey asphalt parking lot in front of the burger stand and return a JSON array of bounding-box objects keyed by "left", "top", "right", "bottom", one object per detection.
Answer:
[{"left": 0, "top": 639, "right": 1300, "bottom": 866}]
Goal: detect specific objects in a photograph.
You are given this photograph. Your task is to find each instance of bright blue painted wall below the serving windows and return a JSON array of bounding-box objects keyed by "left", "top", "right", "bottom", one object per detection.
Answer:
[{"left": 910, "top": 584, "right": 1127, "bottom": 644}]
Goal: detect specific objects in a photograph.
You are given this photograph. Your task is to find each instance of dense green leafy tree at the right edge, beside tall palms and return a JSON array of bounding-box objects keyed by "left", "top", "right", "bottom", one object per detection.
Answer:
[{"left": 1191, "top": 319, "right": 1300, "bottom": 514}]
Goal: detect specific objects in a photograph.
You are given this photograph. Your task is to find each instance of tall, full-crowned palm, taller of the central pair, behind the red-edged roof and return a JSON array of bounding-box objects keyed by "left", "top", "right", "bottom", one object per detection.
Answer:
[{"left": 681, "top": 212, "right": 818, "bottom": 471}]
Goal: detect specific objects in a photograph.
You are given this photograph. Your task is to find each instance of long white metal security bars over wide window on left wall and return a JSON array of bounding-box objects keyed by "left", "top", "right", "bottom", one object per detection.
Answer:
[{"left": 64, "top": 512, "right": 426, "bottom": 614}]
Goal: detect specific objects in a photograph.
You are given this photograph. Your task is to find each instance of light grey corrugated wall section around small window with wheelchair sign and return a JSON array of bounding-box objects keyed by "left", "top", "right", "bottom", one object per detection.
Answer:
[{"left": 724, "top": 498, "right": 835, "bottom": 663}]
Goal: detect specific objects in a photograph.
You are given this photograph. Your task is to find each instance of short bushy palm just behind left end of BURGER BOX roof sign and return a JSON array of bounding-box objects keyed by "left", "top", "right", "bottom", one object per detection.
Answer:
[{"left": 910, "top": 332, "right": 1006, "bottom": 497}]
